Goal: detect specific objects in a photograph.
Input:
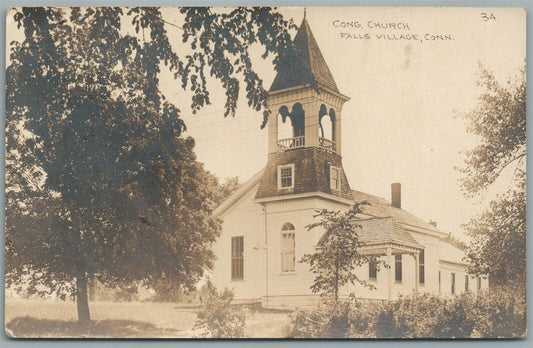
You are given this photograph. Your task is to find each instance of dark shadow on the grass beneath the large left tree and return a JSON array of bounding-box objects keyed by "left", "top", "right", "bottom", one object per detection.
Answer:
[{"left": 6, "top": 317, "right": 176, "bottom": 338}]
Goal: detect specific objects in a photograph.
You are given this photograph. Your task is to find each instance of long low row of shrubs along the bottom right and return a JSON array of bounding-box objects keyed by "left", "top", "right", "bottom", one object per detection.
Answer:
[{"left": 292, "top": 289, "right": 526, "bottom": 338}]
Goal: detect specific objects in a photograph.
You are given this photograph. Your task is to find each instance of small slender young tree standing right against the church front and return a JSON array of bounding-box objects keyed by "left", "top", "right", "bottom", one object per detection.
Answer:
[{"left": 300, "top": 202, "right": 384, "bottom": 302}]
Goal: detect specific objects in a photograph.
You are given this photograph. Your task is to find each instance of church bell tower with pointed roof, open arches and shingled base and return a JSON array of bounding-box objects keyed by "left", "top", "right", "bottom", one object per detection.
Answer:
[{"left": 256, "top": 16, "right": 352, "bottom": 201}]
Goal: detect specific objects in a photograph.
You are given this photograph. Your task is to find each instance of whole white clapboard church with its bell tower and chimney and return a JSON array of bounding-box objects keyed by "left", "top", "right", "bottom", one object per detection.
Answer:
[{"left": 211, "top": 18, "right": 488, "bottom": 308}]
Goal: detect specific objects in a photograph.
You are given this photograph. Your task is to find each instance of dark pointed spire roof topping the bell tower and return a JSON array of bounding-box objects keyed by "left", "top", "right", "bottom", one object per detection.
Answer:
[{"left": 270, "top": 18, "right": 339, "bottom": 93}]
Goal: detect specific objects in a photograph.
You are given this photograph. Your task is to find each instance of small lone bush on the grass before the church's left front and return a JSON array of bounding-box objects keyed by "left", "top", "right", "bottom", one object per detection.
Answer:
[{"left": 195, "top": 282, "right": 246, "bottom": 338}]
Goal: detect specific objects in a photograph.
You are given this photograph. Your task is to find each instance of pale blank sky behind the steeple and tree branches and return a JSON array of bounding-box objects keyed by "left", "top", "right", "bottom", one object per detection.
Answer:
[{"left": 6, "top": 7, "right": 526, "bottom": 239}]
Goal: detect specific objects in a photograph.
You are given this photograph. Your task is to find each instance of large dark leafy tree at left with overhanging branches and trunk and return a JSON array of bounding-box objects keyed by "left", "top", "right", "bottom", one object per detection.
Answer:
[{"left": 6, "top": 7, "right": 293, "bottom": 321}]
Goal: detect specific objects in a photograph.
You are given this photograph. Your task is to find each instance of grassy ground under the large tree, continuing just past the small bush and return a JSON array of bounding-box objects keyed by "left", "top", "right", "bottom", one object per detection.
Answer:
[{"left": 5, "top": 298, "right": 290, "bottom": 338}]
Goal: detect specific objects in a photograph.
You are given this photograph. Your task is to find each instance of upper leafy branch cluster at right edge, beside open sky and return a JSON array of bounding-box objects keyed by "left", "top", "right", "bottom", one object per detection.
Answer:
[{"left": 461, "top": 64, "right": 527, "bottom": 194}]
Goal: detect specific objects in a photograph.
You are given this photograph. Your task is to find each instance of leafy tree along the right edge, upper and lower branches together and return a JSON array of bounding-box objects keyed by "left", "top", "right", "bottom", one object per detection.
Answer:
[{"left": 461, "top": 64, "right": 527, "bottom": 286}]
